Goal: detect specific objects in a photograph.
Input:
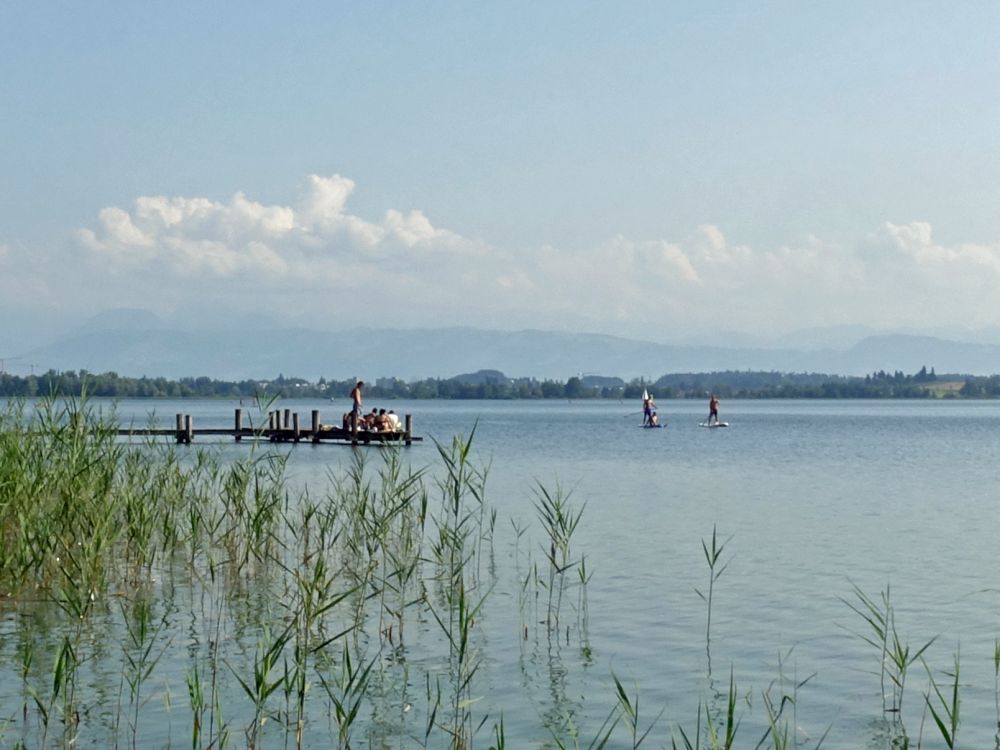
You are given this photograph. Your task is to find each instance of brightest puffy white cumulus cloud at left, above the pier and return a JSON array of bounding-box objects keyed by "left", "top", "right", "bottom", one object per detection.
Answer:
[{"left": 78, "top": 175, "right": 472, "bottom": 285}]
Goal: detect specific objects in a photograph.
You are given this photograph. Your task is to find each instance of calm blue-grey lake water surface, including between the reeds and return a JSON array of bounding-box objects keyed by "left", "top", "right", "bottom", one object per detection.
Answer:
[{"left": 0, "top": 401, "right": 1000, "bottom": 748}]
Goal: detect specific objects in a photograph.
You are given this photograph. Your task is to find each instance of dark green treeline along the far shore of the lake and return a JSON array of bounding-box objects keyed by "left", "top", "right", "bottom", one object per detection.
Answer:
[{"left": 0, "top": 367, "right": 1000, "bottom": 399}]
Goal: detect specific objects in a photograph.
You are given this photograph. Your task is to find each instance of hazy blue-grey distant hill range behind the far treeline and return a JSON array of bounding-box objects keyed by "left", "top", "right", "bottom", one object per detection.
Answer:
[{"left": 17, "top": 320, "right": 1000, "bottom": 381}]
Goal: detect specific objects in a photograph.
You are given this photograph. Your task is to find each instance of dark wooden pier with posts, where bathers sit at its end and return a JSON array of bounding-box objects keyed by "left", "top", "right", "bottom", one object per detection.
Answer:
[{"left": 118, "top": 409, "right": 422, "bottom": 445}]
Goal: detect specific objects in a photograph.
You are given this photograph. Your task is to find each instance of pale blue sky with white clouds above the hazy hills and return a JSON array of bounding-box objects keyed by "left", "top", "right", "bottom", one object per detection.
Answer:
[{"left": 0, "top": 0, "right": 1000, "bottom": 357}]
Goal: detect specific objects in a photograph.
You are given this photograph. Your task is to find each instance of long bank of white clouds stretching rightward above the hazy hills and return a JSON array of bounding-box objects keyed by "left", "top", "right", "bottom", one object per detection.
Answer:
[{"left": 64, "top": 175, "right": 1000, "bottom": 336}]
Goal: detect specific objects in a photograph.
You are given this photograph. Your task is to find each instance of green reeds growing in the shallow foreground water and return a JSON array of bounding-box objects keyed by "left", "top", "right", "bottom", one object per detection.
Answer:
[{"left": 0, "top": 399, "right": 1000, "bottom": 750}]
